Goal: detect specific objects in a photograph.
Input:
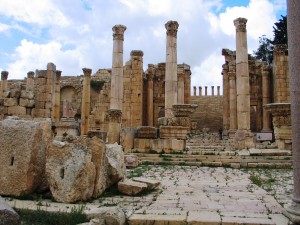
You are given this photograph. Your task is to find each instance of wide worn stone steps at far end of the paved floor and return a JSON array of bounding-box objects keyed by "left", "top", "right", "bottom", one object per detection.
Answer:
[{"left": 131, "top": 133, "right": 292, "bottom": 168}]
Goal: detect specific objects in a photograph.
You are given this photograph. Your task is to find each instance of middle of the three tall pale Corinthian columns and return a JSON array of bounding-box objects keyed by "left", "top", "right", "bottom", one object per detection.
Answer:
[{"left": 165, "top": 21, "right": 179, "bottom": 118}]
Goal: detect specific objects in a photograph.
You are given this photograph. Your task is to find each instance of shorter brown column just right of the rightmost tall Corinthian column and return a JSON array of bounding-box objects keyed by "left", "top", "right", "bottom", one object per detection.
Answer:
[{"left": 261, "top": 63, "right": 272, "bottom": 133}]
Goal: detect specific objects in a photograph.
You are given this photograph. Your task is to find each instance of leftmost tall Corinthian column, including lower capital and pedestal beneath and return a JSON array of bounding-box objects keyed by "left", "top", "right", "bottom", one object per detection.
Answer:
[{"left": 107, "top": 25, "right": 126, "bottom": 144}]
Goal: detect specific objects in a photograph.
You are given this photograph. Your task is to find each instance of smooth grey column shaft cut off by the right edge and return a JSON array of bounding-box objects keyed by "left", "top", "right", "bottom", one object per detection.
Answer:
[{"left": 286, "top": 0, "right": 300, "bottom": 221}]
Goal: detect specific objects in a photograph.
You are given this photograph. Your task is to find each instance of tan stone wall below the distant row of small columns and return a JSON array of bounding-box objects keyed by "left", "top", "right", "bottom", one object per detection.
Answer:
[{"left": 191, "top": 93, "right": 223, "bottom": 132}]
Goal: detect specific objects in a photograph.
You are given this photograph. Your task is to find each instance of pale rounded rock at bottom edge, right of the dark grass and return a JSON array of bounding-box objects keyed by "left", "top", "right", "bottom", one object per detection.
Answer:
[{"left": 87, "top": 207, "right": 126, "bottom": 225}]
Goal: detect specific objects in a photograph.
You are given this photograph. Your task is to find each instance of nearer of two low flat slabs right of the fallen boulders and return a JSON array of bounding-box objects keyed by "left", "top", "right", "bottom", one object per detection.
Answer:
[{"left": 118, "top": 180, "right": 147, "bottom": 195}]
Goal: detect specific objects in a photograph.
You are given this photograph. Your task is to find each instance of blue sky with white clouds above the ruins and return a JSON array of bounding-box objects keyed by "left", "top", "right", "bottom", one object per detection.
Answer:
[{"left": 0, "top": 0, "right": 286, "bottom": 93}]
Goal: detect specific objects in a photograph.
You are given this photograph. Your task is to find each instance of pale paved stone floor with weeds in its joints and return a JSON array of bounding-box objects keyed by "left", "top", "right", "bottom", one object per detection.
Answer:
[{"left": 4, "top": 166, "right": 293, "bottom": 225}]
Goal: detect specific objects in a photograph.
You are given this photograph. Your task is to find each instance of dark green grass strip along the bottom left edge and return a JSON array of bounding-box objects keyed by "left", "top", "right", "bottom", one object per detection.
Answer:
[{"left": 15, "top": 205, "right": 89, "bottom": 225}]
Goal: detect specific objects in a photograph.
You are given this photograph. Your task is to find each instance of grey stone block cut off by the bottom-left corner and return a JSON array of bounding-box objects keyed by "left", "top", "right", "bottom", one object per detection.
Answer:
[{"left": 0, "top": 196, "right": 21, "bottom": 225}]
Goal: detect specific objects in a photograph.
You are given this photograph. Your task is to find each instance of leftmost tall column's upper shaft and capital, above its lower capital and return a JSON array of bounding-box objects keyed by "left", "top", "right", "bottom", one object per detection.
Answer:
[{"left": 110, "top": 25, "right": 126, "bottom": 110}]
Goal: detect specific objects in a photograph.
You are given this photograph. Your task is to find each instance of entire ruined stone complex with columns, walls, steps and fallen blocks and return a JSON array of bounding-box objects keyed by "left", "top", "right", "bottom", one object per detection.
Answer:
[{"left": 0, "top": 14, "right": 298, "bottom": 224}]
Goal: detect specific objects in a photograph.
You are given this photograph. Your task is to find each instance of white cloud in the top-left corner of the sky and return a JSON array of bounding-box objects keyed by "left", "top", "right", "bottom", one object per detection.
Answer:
[{"left": 0, "top": 0, "right": 69, "bottom": 26}]
